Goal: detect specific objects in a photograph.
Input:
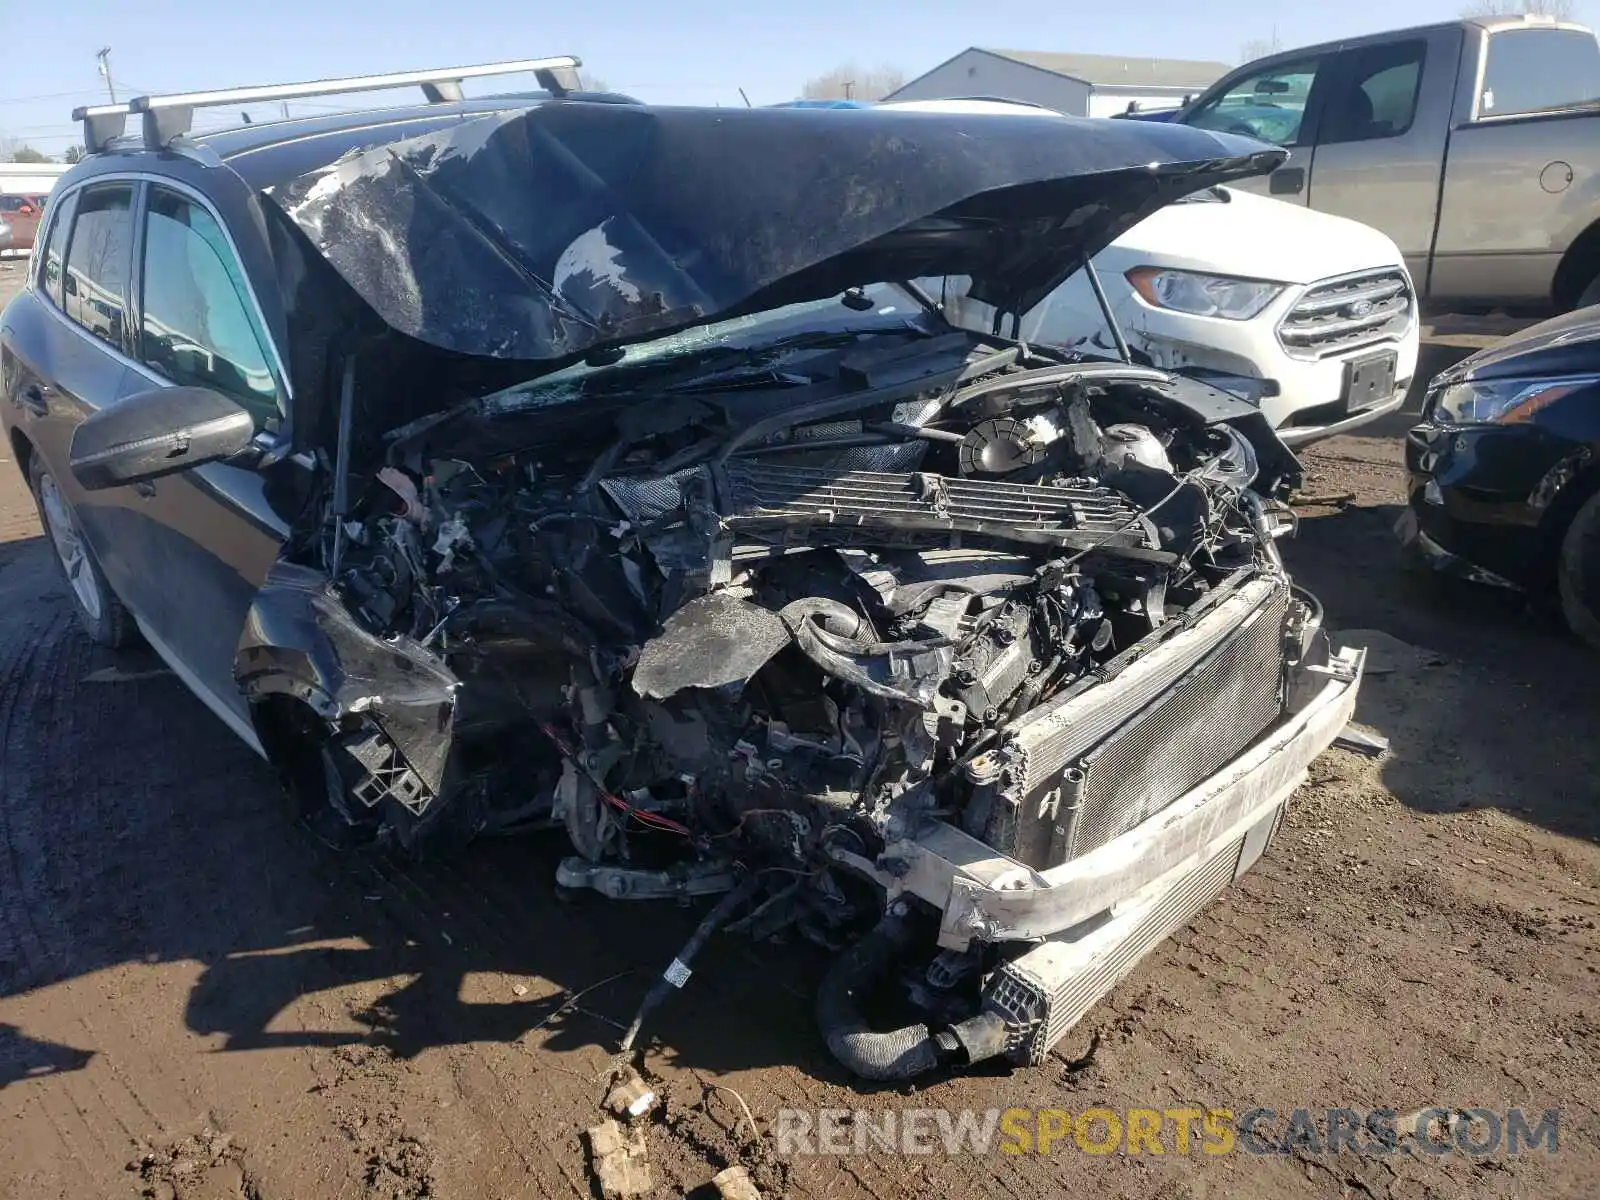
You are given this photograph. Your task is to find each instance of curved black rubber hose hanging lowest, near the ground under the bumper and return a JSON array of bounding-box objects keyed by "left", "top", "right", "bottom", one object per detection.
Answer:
[{"left": 816, "top": 914, "right": 941, "bottom": 1080}]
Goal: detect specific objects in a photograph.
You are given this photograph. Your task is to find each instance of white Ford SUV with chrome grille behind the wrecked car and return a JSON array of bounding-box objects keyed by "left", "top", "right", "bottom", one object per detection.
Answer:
[{"left": 883, "top": 99, "right": 1418, "bottom": 446}]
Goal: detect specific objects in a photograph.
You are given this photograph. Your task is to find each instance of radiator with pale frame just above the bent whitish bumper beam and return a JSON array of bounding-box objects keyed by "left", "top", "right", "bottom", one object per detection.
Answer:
[{"left": 970, "top": 576, "right": 1290, "bottom": 870}]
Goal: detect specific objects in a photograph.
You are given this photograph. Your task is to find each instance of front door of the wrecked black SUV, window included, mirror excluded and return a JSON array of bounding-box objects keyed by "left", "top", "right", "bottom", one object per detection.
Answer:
[{"left": 116, "top": 181, "right": 306, "bottom": 736}]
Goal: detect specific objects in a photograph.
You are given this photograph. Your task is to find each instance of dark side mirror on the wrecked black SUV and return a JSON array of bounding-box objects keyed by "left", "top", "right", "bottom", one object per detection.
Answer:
[{"left": 67, "top": 387, "right": 256, "bottom": 491}]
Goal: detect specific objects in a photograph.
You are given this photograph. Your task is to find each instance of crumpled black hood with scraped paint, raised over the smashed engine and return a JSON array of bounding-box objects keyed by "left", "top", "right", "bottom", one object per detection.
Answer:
[{"left": 272, "top": 101, "right": 1285, "bottom": 366}]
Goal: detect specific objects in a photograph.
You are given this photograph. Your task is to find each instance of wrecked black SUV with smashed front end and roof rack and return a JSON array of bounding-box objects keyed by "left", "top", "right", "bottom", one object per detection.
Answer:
[{"left": 3, "top": 59, "right": 1362, "bottom": 1078}]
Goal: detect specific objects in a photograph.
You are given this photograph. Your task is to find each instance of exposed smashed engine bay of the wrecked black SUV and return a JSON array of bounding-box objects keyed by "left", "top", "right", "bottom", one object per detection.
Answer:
[{"left": 256, "top": 325, "right": 1337, "bottom": 1077}]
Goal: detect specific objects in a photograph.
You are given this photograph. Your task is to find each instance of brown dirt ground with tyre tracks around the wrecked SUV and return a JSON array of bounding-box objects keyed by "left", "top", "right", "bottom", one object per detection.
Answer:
[{"left": 0, "top": 262, "right": 1600, "bottom": 1200}]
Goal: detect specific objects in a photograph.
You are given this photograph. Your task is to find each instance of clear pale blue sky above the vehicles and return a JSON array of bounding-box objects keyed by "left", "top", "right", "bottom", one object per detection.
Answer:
[{"left": 0, "top": 0, "right": 1600, "bottom": 155}]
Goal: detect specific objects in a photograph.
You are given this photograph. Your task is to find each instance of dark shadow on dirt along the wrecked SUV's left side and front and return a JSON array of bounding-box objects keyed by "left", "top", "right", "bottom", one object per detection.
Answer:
[{"left": 0, "top": 538, "right": 837, "bottom": 1075}]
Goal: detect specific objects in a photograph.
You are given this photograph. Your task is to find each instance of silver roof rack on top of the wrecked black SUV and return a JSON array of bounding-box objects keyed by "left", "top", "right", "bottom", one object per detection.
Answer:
[{"left": 72, "top": 54, "right": 582, "bottom": 154}]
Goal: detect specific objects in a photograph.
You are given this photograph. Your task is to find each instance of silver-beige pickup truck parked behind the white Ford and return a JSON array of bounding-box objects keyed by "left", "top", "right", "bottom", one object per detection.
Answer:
[{"left": 1171, "top": 18, "right": 1600, "bottom": 309}]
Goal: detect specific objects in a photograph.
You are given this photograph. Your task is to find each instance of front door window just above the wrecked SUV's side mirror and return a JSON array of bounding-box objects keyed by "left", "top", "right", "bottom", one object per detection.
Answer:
[{"left": 141, "top": 187, "right": 278, "bottom": 427}]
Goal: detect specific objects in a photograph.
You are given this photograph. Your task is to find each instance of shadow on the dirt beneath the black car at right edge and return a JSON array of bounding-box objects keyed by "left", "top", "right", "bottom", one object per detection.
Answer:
[{"left": 1285, "top": 504, "right": 1600, "bottom": 838}]
